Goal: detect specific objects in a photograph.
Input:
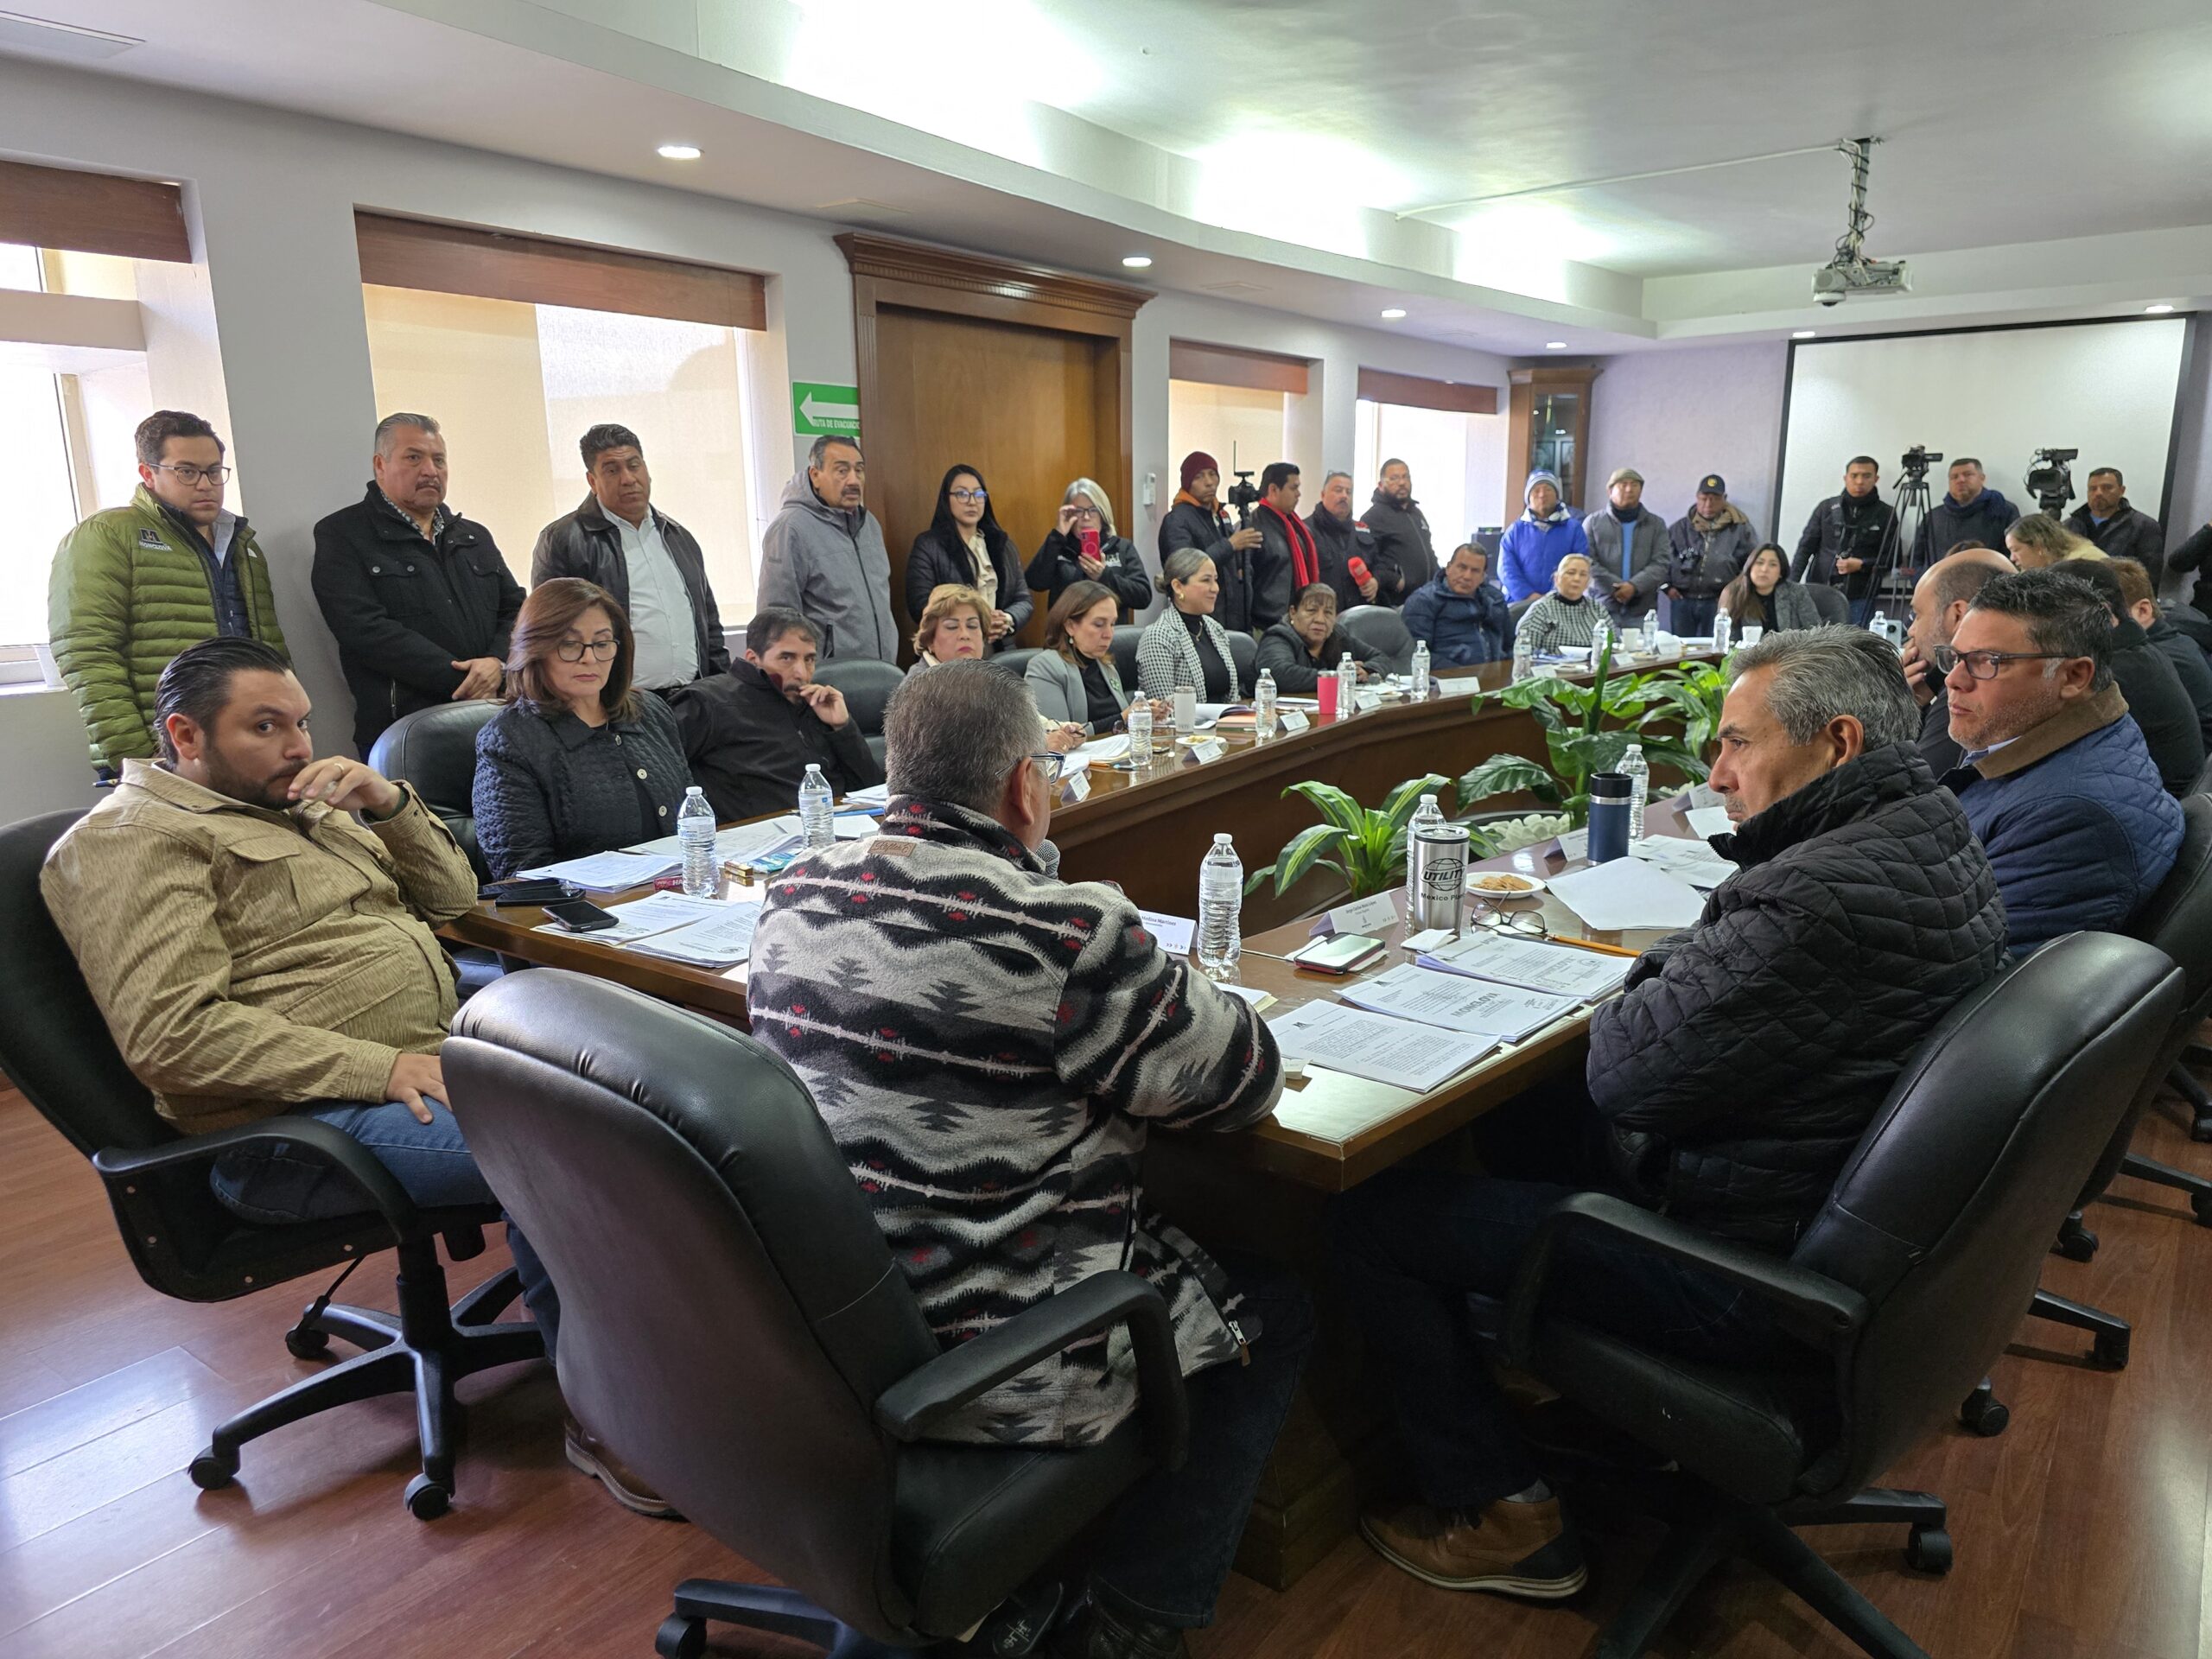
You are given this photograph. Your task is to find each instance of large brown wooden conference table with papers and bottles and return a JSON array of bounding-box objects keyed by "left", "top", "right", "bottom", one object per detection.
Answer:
[{"left": 442, "top": 666, "right": 1716, "bottom": 1588}]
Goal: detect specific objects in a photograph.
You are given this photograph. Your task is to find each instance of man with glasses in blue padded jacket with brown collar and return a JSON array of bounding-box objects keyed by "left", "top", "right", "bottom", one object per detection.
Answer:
[{"left": 1933, "top": 570, "right": 2181, "bottom": 956}]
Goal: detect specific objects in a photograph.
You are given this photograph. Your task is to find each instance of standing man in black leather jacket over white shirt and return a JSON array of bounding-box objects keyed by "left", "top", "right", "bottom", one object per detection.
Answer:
[{"left": 531, "top": 423, "right": 730, "bottom": 692}]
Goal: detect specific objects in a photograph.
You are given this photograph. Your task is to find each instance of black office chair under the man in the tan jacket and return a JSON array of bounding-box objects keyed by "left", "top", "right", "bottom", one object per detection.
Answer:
[{"left": 0, "top": 812, "right": 544, "bottom": 1520}]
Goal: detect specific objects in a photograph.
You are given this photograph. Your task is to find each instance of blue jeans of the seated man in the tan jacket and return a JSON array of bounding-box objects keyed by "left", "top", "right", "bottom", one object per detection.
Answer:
[{"left": 208, "top": 1099, "right": 560, "bottom": 1358}]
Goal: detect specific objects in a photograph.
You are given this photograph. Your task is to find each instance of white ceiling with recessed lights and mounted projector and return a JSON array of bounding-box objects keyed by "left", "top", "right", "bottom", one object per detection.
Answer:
[{"left": 0, "top": 0, "right": 2212, "bottom": 354}]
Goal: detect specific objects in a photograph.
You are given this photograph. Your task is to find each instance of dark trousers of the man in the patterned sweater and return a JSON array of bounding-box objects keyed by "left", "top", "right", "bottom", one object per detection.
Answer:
[{"left": 1090, "top": 1252, "right": 1314, "bottom": 1630}]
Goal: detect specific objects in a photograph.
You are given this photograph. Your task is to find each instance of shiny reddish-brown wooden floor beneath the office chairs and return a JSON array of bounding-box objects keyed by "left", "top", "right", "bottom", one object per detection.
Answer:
[{"left": 0, "top": 1090, "right": 2212, "bottom": 1659}]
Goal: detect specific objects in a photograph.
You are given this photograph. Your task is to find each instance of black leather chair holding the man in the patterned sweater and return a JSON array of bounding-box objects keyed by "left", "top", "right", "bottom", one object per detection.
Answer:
[{"left": 442, "top": 969, "right": 1188, "bottom": 1659}]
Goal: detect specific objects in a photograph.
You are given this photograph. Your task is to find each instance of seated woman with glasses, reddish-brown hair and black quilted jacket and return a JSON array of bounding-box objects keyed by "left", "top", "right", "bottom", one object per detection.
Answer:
[{"left": 475, "top": 575, "right": 692, "bottom": 880}]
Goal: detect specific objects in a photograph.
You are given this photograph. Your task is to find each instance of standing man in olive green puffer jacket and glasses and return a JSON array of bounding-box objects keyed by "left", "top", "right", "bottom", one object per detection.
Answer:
[{"left": 47, "top": 410, "right": 285, "bottom": 777}]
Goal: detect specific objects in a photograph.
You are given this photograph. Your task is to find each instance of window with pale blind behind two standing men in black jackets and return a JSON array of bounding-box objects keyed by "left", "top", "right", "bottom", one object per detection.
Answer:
[{"left": 363, "top": 285, "right": 754, "bottom": 610}]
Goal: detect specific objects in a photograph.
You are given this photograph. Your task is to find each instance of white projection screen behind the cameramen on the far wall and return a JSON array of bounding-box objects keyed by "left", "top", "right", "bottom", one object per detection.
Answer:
[{"left": 1774, "top": 316, "right": 2188, "bottom": 553}]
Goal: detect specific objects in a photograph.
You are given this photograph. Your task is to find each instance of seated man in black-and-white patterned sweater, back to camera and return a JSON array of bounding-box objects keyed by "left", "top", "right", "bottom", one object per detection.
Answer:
[{"left": 747, "top": 664, "right": 1314, "bottom": 1659}]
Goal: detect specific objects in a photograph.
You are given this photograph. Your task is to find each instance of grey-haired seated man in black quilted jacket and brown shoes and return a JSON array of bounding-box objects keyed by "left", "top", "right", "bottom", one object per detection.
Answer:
[{"left": 1336, "top": 626, "right": 2004, "bottom": 1599}]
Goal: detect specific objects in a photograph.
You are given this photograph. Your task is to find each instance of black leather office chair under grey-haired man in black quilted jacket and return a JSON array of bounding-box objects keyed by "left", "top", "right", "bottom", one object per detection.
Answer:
[{"left": 1506, "top": 933, "right": 2183, "bottom": 1659}]
